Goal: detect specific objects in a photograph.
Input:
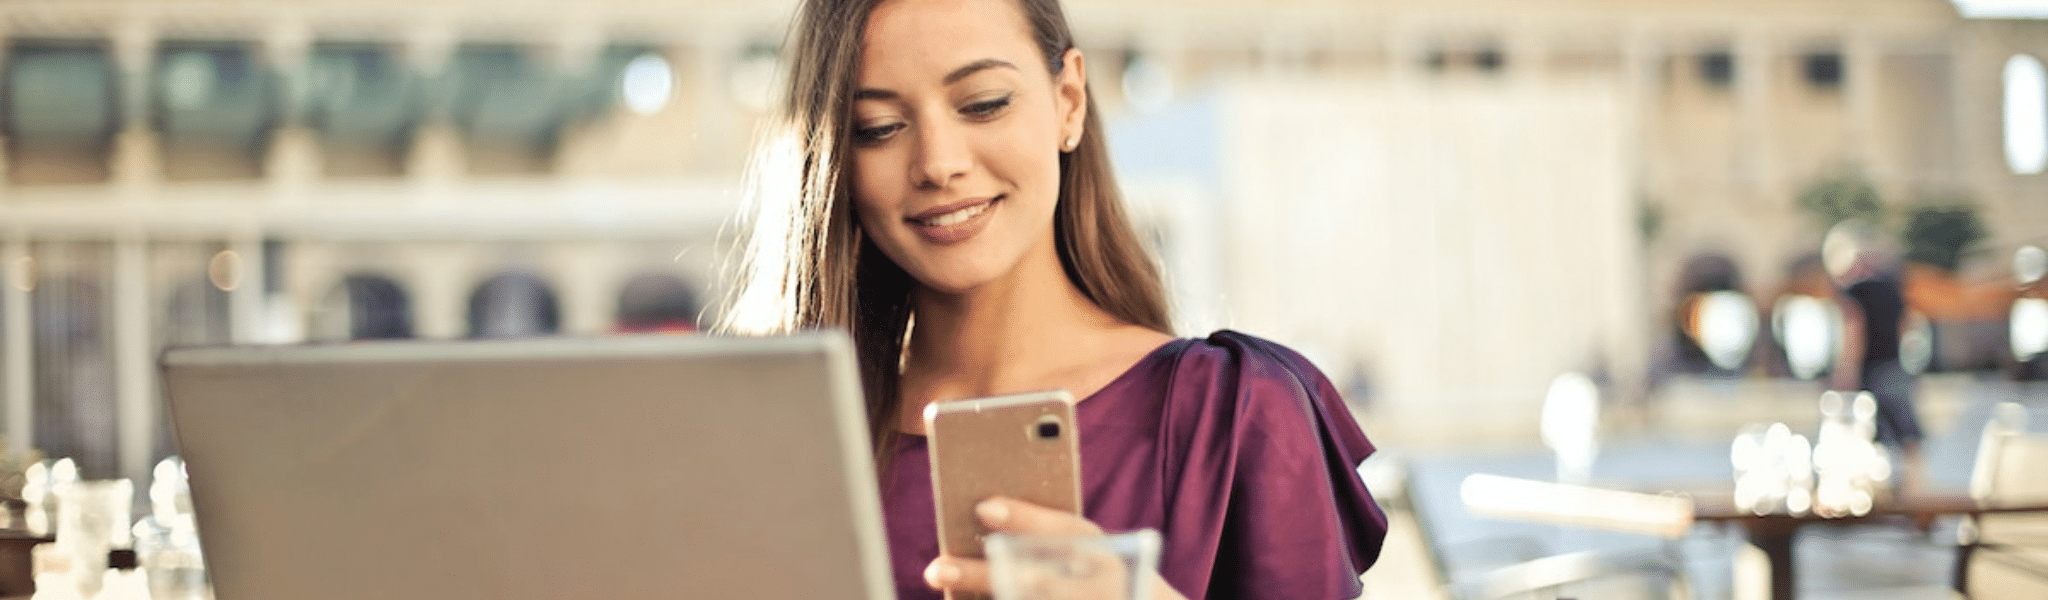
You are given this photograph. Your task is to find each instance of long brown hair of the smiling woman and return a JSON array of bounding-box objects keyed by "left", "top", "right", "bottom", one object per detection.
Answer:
[{"left": 725, "top": 0, "right": 1171, "bottom": 457}]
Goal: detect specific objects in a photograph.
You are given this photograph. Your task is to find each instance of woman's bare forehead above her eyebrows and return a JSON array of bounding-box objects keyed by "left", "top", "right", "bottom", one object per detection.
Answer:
[{"left": 860, "top": 0, "right": 1044, "bottom": 86}]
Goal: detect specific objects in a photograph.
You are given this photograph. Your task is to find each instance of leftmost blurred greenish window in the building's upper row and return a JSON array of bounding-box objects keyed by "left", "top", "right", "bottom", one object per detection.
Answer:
[{"left": 0, "top": 41, "right": 121, "bottom": 184}]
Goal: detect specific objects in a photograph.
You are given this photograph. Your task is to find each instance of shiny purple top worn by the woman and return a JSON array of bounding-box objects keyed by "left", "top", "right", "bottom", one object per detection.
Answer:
[{"left": 883, "top": 330, "right": 1386, "bottom": 600}]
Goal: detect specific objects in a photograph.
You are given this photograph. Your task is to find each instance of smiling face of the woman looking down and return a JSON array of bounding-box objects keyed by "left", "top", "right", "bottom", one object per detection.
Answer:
[{"left": 852, "top": 0, "right": 1087, "bottom": 293}]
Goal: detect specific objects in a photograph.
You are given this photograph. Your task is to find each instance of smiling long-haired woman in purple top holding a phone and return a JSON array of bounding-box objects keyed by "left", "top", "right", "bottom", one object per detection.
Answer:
[{"left": 735, "top": 0, "right": 1386, "bottom": 598}]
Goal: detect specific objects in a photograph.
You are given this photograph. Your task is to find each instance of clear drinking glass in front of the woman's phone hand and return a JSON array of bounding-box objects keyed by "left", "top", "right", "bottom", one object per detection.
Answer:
[{"left": 985, "top": 528, "right": 1159, "bottom": 600}]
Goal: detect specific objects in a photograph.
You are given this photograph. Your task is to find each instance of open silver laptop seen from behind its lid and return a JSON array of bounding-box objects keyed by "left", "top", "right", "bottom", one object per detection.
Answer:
[{"left": 164, "top": 334, "right": 893, "bottom": 600}]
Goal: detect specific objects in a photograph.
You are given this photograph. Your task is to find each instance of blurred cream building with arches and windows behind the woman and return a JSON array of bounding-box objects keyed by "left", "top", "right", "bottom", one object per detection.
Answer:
[{"left": 0, "top": 0, "right": 2048, "bottom": 495}]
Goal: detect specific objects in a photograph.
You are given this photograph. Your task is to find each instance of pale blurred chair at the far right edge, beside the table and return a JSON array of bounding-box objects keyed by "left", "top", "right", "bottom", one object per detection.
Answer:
[{"left": 1956, "top": 401, "right": 2048, "bottom": 598}]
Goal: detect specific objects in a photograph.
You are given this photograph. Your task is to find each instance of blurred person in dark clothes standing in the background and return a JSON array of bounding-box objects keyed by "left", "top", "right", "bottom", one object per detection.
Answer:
[{"left": 1821, "top": 219, "right": 1923, "bottom": 489}]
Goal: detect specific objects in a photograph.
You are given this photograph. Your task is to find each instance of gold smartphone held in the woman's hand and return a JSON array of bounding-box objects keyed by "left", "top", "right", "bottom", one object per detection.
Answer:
[{"left": 924, "top": 389, "right": 1081, "bottom": 600}]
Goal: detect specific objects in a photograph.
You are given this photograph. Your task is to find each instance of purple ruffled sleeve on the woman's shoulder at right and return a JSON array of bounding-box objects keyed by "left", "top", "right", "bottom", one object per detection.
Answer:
[{"left": 1159, "top": 330, "right": 1386, "bottom": 598}]
